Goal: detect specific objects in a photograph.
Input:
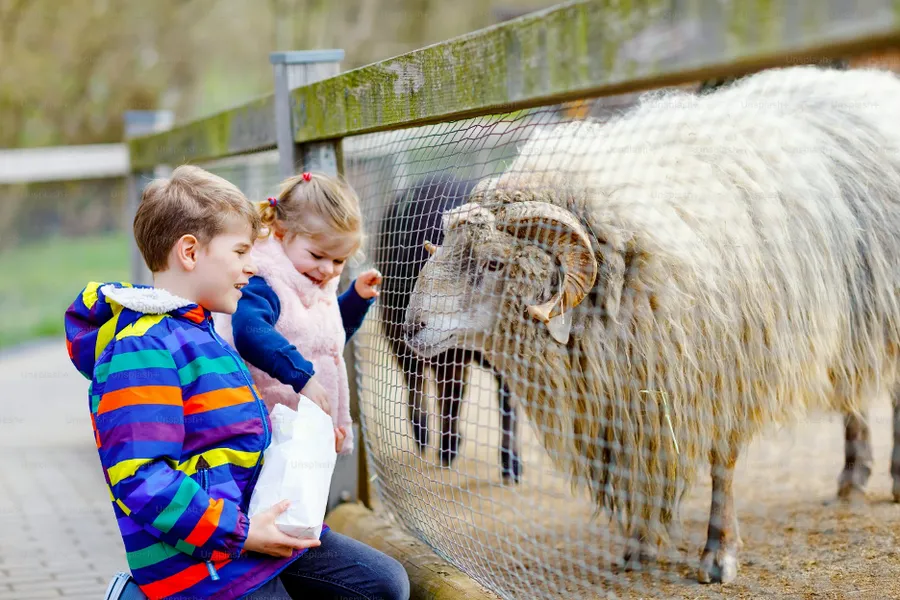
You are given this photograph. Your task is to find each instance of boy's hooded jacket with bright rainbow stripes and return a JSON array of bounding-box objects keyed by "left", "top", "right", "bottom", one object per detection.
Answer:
[{"left": 65, "top": 282, "right": 328, "bottom": 599}]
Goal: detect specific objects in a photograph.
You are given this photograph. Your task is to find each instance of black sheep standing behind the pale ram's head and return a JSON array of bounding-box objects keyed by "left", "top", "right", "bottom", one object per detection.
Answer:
[{"left": 375, "top": 174, "right": 522, "bottom": 483}]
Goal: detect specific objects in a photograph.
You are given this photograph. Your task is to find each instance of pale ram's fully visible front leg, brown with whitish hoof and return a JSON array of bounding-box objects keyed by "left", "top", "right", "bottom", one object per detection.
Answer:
[{"left": 697, "top": 444, "right": 743, "bottom": 583}]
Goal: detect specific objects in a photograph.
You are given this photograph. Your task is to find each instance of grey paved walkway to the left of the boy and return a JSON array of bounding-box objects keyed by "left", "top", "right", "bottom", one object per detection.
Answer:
[{"left": 0, "top": 340, "right": 125, "bottom": 600}]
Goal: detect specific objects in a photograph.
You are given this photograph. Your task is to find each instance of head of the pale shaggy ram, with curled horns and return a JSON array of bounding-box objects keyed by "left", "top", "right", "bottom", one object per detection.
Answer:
[{"left": 404, "top": 177, "right": 624, "bottom": 357}]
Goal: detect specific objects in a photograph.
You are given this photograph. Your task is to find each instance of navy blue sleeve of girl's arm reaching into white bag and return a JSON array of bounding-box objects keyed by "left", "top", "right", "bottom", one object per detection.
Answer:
[{"left": 231, "top": 276, "right": 315, "bottom": 394}]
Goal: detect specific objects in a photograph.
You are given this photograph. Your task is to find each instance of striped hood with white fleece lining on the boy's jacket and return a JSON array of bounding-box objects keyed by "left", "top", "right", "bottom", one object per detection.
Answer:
[{"left": 65, "top": 281, "right": 203, "bottom": 379}]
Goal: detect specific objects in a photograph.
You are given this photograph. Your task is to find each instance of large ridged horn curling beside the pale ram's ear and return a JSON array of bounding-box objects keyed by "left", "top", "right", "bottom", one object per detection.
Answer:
[{"left": 498, "top": 201, "right": 597, "bottom": 323}]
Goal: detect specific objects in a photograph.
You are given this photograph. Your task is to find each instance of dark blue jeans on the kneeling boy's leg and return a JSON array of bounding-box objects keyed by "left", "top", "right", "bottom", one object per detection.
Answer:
[{"left": 244, "top": 530, "right": 409, "bottom": 600}]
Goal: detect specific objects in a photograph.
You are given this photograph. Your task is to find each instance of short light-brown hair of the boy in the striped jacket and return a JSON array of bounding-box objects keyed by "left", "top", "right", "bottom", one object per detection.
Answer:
[{"left": 134, "top": 165, "right": 260, "bottom": 273}]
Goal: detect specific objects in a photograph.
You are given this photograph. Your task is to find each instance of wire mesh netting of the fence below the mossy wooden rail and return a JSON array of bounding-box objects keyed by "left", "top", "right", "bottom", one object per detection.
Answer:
[{"left": 343, "top": 71, "right": 900, "bottom": 598}]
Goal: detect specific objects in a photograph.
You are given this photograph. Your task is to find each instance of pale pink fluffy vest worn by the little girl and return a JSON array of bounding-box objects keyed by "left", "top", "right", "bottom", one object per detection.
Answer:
[{"left": 215, "top": 237, "right": 354, "bottom": 454}]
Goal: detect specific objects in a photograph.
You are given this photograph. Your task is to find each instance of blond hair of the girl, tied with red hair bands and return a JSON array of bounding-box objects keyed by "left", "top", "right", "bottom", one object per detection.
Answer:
[{"left": 258, "top": 173, "right": 362, "bottom": 251}]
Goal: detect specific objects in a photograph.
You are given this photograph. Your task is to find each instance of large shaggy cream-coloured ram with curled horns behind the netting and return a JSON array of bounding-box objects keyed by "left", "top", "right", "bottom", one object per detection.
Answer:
[{"left": 405, "top": 67, "right": 900, "bottom": 582}]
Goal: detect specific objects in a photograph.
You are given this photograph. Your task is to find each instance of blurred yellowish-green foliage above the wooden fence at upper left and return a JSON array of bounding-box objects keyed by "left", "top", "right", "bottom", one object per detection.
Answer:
[{"left": 0, "top": 0, "right": 556, "bottom": 148}]
